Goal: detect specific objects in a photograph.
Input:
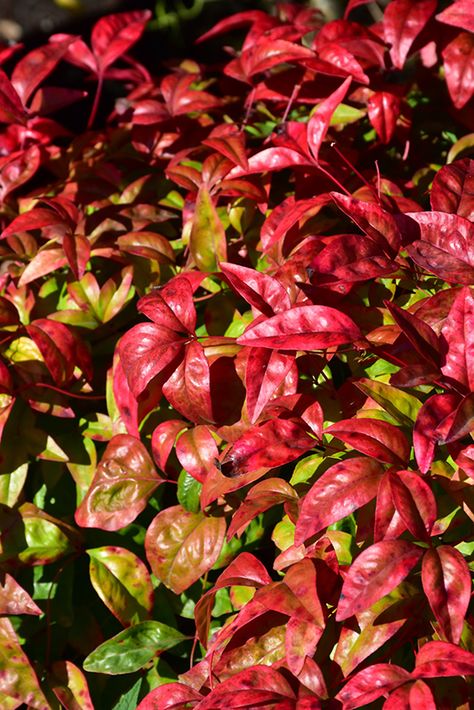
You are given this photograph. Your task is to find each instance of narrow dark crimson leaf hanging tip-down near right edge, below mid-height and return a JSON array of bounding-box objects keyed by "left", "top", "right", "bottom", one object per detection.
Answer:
[{"left": 413, "top": 394, "right": 459, "bottom": 473}]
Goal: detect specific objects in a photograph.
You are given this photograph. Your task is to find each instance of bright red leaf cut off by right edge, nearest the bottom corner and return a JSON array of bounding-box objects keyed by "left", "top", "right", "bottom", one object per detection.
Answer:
[{"left": 412, "top": 641, "right": 474, "bottom": 678}]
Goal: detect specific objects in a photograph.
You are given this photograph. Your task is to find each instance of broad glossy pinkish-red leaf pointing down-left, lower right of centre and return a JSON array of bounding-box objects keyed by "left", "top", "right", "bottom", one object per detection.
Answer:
[{"left": 295, "top": 458, "right": 383, "bottom": 545}]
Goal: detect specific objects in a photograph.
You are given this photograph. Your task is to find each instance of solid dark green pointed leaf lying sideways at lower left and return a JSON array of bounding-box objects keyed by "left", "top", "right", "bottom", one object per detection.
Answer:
[{"left": 84, "top": 621, "right": 187, "bottom": 675}]
